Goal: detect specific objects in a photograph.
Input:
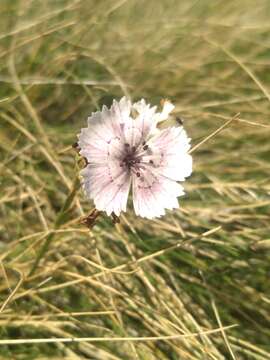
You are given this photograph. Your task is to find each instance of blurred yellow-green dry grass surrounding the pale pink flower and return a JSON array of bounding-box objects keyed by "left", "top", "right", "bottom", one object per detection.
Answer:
[{"left": 0, "top": 0, "right": 270, "bottom": 360}]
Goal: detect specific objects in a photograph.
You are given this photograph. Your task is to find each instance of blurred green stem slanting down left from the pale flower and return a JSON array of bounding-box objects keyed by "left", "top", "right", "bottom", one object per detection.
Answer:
[{"left": 29, "top": 177, "right": 80, "bottom": 276}]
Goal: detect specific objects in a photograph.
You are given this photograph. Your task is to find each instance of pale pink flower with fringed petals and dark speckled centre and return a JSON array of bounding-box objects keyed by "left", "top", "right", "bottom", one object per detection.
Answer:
[{"left": 78, "top": 97, "right": 192, "bottom": 219}]
